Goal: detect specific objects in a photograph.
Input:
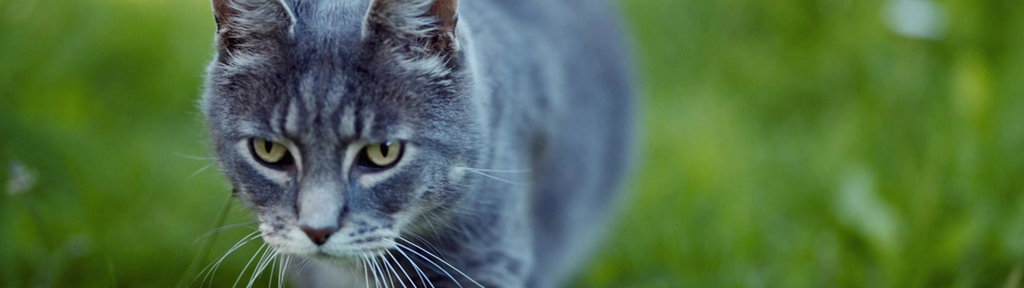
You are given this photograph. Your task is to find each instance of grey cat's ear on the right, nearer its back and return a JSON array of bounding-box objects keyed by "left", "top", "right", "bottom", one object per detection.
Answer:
[{"left": 362, "top": 0, "right": 459, "bottom": 54}]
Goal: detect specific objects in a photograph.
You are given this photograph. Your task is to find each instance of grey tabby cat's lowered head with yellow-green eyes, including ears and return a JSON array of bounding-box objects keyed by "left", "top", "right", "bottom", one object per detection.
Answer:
[{"left": 202, "top": 0, "right": 487, "bottom": 258}]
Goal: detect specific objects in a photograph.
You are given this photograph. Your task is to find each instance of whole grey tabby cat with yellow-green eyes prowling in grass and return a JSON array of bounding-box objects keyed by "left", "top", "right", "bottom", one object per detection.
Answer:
[{"left": 201, "top": 0, "right": 634, "bottom": 287}]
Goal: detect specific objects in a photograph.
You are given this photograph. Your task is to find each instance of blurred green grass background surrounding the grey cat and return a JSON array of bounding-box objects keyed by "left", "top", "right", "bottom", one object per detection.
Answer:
[{"left": 0, "top": 0, "right": 1024, "bottom": 287}]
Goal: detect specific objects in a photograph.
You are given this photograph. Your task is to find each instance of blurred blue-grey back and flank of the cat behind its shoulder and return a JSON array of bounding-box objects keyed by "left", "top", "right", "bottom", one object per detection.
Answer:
[{"left": 462, "top": 0, "right": 635, "bottom": 287}]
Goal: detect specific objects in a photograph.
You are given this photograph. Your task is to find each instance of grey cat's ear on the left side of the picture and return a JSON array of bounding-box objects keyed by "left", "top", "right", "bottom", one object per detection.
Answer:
[{"left": 213, "top": 0, "right": 295, "bottom": 54}]
